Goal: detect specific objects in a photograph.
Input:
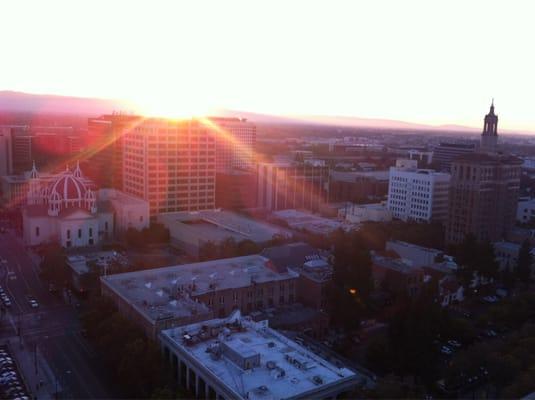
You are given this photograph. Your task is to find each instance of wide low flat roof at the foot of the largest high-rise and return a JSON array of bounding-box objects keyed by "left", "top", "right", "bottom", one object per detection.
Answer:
[{"left": 157, "top": 210, "right": 292, "bottom": 243}]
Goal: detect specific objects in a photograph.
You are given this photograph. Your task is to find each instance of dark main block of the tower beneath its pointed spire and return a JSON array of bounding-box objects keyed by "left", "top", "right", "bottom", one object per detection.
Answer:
[{"left": 446, "top": 153, "right": 522, "bottom": 243}]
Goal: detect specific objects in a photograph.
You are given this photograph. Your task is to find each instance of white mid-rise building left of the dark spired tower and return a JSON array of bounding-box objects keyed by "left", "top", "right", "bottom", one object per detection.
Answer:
[{"left": 387, "top": 160, "right": 450, "bottom": 222}]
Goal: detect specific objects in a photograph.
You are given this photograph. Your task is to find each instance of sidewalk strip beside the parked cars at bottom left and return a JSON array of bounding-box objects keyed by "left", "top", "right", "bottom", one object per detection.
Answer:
[{"left": 8, "top": 336, "right": 61, "bottom": 400}]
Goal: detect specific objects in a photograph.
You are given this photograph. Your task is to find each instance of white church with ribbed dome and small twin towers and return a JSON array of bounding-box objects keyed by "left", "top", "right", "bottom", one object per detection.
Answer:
[{"left": 22, "top": 165, "right": 149, "bottom": 248}]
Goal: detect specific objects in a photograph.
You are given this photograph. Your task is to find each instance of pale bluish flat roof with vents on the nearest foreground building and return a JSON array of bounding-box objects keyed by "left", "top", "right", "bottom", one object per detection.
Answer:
[{"left": 161, "top": 311, "right": 364, "bottom": 399}]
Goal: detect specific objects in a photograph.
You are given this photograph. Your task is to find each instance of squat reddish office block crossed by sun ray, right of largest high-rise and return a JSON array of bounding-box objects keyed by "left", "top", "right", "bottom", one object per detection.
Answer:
[{"left": 257, "top": 162, "right": 329, "bottom": 211}]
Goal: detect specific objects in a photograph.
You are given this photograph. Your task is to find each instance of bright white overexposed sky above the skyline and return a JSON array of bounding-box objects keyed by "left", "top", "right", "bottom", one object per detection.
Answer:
[{"left": 0, "top": 0, "right": 535, "bottom": 131}]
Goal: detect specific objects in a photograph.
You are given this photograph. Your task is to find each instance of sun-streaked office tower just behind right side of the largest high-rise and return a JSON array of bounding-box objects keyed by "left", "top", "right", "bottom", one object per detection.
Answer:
[{"left": 207, "top": 117, "right": 256, "bottom": 173}]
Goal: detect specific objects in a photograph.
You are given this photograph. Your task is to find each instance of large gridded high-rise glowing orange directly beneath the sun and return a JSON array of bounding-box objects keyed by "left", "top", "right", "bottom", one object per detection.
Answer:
[{"left": 121, "top": 117, "right": 216, "bottom": 216}]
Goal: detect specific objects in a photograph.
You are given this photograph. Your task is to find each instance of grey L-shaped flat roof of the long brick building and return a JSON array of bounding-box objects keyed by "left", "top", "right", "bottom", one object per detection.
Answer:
[{"left": 101, "top": 255, "right": 298, "bottom": 322}]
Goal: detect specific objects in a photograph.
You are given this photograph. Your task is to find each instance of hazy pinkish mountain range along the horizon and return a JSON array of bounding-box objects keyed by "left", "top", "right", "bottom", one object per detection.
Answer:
[{"left": 0, "top": 91, "right": 496, "bottom": 133}]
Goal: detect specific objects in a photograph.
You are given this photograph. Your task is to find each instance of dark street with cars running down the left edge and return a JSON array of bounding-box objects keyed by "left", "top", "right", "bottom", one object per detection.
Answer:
[{"left": 0, "top": 231, "right": 112, "bottom": 398}]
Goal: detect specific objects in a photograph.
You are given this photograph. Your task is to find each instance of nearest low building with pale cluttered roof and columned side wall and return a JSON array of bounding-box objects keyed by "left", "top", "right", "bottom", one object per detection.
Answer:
[{"left": 160, "top": 312, "right": 366, "bottom": 400}]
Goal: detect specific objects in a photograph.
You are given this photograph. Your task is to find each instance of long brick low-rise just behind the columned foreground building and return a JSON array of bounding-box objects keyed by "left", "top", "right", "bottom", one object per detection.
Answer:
[{"left": 100, "top": 255, "right": 299, "bottom": 337}]
